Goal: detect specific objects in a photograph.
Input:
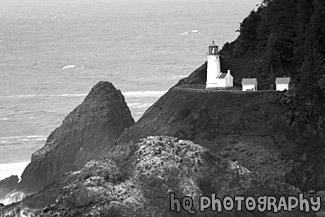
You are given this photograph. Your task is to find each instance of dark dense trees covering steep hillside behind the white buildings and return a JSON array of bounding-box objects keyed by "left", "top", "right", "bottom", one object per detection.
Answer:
[{"left": 222, "top": 0, "right": 325, "bottom": 139}]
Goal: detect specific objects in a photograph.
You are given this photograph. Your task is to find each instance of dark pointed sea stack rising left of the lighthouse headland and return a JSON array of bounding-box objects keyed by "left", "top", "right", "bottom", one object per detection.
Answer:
[{"left": 19, "top": 82, "right": 134, "bottom": 192}]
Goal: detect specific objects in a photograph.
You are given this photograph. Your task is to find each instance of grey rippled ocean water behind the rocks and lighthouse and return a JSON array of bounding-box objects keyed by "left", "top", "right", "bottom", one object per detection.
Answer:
[{"left": 0, "top": 0, "right": 260, "bottom": 180}]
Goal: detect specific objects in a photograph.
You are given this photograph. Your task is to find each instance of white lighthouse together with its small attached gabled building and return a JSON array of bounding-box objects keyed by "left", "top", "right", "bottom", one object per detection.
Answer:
[{"left": 206, "top": 41, "right": 233, "bottom": 88}]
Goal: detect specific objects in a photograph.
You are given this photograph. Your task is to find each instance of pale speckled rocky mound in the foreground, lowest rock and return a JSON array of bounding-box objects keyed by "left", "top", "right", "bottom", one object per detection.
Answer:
[{"left": 2, "top": 136, "right": 315, "bottom": 217}]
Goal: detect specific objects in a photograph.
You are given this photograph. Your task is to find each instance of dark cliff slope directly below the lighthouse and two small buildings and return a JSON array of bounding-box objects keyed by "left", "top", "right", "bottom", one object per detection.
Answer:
[{"left": 115, "top": 80, "right": 325, "bottom": 190}]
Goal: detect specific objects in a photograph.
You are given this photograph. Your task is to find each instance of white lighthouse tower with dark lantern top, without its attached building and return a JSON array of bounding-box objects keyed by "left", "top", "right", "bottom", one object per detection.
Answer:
[{"left": 206, "top": 41, "right": 221, "bottom": 88}]
